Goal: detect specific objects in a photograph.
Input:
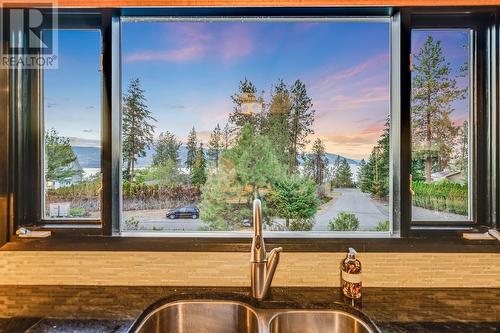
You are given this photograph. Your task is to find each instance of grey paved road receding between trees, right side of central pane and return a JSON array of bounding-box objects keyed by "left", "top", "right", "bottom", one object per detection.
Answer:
[{"left": 313, "top": 188, "right": 388, "bottom": 231}]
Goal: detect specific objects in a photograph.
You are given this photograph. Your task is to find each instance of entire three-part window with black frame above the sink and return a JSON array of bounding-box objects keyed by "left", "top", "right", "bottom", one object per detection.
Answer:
[{"left": 4, "top": 9, "right": 499, "bottom": 238}]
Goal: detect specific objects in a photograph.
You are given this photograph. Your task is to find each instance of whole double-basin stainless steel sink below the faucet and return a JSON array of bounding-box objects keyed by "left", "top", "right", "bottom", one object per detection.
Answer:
[{"left": 129, "top": 299, "right": 380, "bottom": 333}]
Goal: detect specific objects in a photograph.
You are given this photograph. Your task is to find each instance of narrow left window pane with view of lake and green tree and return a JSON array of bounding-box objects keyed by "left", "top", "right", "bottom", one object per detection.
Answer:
[{"left": 42, "top": 29, "right": 101, "bottom": 219}]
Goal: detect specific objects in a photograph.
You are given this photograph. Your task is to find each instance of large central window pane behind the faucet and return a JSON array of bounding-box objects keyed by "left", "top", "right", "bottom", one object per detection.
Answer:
[{"left": 121, "top": 18, "right": 391, "bottom": 232}]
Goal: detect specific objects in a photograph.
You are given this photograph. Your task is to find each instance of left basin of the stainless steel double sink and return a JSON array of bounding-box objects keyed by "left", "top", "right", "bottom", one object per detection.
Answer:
[{"left": 131, "top": 301, "right": 259, "bottom": 333}]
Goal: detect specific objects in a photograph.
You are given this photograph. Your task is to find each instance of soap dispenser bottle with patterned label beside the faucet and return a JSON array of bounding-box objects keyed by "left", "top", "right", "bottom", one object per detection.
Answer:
[{"left": 340, "top": 247, "right": 361, "bottom": 299}]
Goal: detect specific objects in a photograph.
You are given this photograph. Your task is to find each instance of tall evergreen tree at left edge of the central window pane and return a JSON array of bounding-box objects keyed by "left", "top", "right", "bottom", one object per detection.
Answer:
[{"left": 123, "top": 79, "right": 156, "bottom": 180}]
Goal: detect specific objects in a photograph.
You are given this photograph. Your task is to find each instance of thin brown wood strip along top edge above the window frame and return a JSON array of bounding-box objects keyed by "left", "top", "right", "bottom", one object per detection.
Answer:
[{"left": 2, "top": 0, "right": 500, "bottom": 8}]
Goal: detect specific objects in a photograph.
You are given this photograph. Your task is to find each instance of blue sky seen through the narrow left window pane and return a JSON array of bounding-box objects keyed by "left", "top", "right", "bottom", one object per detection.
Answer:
[{"left": 44, "top": 30, "right": 101, "bottom": 145}]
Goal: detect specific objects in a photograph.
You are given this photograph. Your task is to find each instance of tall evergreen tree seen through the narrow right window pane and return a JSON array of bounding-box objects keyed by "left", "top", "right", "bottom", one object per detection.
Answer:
[{"left": 411, "top": 36, "right": 465, "bottom": 182}]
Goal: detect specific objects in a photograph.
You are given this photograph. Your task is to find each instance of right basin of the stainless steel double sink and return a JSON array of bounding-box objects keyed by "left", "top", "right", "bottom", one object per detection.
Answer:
[{"left": 269, "top": 310, "right": 375, "bottom": 333}]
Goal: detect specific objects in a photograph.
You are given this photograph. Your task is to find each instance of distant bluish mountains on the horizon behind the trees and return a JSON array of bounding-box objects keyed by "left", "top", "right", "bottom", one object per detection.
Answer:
[{"left": 73, "top": 146, "right": 360, "bottom": 168}]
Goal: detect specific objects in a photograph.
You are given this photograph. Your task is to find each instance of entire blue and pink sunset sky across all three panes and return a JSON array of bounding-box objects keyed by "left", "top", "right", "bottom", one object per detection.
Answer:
[{"left": 45, "top": 22, "right": 467, "bottom": 159}]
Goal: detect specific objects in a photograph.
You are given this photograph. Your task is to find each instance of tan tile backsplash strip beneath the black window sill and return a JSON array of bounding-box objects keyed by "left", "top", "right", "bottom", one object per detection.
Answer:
[{"left": 0, "top": 251, "right": 500, "bottom": 288}]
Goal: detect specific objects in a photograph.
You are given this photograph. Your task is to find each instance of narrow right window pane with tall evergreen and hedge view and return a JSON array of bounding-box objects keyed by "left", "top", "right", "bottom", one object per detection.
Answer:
[{"left": 411, "top": 29, "right": 474, "bottom": 222}]
